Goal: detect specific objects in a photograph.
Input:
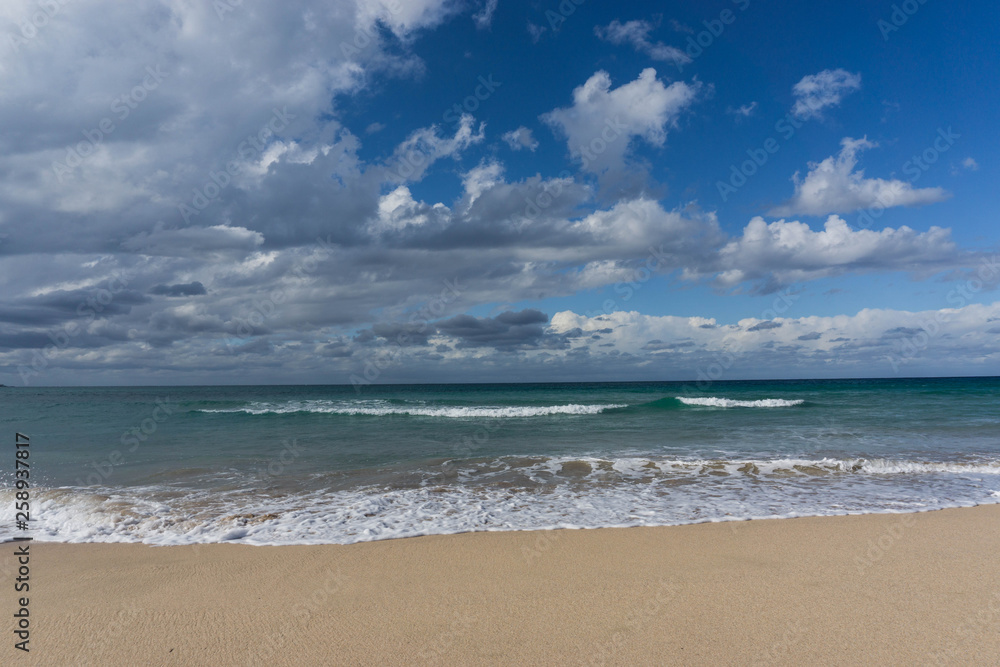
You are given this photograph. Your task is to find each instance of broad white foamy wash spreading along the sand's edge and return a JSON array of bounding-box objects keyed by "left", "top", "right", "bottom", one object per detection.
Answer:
[{"left": 0, "top": 456, "right": 1000, "bottom": 545}]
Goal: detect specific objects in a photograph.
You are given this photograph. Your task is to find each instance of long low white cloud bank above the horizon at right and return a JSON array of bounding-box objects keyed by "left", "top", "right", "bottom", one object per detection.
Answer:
[{"left": 549, "top": 300, "right": 1000, "bottom": 380}]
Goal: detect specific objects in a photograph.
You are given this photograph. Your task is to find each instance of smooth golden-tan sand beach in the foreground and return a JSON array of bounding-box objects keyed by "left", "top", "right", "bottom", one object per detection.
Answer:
[{"left": 0, "top": 506, "right": 1000, "bottom": 665}]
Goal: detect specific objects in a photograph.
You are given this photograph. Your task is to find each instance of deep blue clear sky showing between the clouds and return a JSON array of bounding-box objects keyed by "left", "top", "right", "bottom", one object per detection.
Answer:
[{"left": 338, "top": 1, "right": 1000, "bottom": 320}]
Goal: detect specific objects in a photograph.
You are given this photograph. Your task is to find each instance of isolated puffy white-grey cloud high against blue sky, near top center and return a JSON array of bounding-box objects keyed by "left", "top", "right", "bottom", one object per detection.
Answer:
[{"left": 541, "top": 68, "right": 701, "bottom": 173}]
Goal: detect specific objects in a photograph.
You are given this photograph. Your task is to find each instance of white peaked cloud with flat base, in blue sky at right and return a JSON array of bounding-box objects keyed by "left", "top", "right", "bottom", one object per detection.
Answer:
[{"left": 768, "top": 137, "right": 950, "bottom": 216}]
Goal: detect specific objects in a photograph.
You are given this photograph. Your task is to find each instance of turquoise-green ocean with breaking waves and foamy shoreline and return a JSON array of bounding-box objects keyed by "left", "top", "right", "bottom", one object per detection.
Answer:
[{"left": 0, "top": 378, "right": 1000, "bottom": 545}]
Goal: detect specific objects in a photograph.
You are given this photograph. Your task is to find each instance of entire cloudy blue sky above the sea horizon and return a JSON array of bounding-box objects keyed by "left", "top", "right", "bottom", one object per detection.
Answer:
[{"left": 0, "top": 0, "right": 1000, "bottom": 388}]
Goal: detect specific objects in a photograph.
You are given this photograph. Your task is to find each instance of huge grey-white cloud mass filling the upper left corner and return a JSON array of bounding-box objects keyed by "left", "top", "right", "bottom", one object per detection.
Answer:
[{"left": 0, "top": 0, "right": 464, "bottom": 254}]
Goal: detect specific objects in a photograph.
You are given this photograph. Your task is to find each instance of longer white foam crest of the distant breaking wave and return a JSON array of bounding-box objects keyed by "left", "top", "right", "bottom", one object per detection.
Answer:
[{"left": 200, "top": 401, "right": 628, "bottom": 419}]
